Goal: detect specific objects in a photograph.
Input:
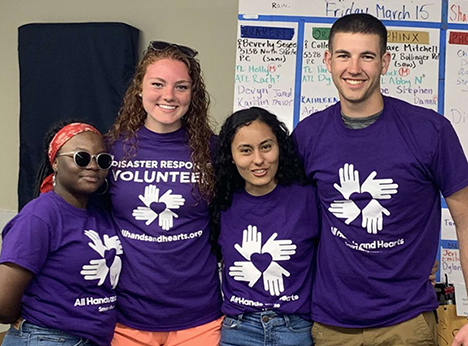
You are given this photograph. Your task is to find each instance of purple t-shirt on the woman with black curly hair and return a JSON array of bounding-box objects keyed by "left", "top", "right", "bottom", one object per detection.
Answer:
[{"left": 219, "top": 185, "right": 319, "bottom": 319}]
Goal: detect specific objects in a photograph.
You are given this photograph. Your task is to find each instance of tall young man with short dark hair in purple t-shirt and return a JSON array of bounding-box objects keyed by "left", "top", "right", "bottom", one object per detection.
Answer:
[{"left": 293, "top": 14, "right": 468, "bottom": 346}]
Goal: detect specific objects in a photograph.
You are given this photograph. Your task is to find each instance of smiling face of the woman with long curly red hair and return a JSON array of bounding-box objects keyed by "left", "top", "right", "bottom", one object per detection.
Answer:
[{"left": 141, "top": 58, "right": 192, "bottom": 133}]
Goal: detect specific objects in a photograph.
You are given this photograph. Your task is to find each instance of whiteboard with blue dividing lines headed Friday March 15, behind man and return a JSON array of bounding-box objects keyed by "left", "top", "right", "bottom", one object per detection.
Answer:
[{"left": 234, "top": 0, "right": 454, "bottom": 131}]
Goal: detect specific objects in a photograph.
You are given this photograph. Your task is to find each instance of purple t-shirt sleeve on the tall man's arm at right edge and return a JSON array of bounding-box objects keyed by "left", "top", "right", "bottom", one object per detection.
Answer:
[{"left": 432, "top": 121, "right": 468, "bottom": 197}]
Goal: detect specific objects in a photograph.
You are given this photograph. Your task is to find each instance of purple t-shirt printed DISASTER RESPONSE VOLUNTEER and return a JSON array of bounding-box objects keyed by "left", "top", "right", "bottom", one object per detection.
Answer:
[{"left": 109, "top": 126, "right": 221, "bottom": 331}]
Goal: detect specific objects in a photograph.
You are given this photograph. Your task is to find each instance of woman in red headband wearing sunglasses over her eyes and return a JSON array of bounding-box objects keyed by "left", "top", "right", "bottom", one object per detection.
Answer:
[{"left": 0, "top": 123, "right": 122, "bottom": 346}]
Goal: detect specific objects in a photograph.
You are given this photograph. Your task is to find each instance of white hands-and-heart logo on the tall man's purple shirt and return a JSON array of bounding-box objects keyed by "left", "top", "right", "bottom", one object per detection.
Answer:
[{"left": 328, "top": 163, "right": 398, "bottom": 234}]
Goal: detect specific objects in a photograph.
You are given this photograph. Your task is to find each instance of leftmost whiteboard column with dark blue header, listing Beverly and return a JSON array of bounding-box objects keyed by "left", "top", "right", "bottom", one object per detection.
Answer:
[{"left": 234, "top": 21, "right": 297, "bottom": 129}]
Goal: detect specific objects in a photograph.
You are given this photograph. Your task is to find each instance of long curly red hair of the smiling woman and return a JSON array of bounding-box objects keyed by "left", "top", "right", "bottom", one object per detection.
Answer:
[{"left": 106, "top": 46, "right": 215, "bottom": 201}]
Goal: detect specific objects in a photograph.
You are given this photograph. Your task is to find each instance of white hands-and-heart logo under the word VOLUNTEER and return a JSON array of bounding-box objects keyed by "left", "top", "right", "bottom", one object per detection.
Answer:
[{"left": 132, "top": 185, "right": 185, "bottom": 231}]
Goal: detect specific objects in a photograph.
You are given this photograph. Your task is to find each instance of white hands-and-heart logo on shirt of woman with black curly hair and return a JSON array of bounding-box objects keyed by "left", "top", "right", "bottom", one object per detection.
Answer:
[{"left": 229, "top": 225, "right": 297, "bottom": 296}]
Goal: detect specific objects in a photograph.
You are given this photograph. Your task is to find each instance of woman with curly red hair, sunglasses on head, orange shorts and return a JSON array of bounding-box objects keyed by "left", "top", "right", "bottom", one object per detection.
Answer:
[{"left": 109, "top": 42, "right": 221, "bottom": 346}]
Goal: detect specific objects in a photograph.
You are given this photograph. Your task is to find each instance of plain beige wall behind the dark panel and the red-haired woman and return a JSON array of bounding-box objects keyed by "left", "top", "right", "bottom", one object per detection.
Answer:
[{"left": 0, "top": 0, "right": 238, "bottom": 214}]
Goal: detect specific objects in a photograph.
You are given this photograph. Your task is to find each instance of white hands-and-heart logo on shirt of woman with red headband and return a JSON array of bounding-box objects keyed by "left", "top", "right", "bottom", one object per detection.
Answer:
[{"left": 80, "top": 230, "right": 123, "bottom": 289}]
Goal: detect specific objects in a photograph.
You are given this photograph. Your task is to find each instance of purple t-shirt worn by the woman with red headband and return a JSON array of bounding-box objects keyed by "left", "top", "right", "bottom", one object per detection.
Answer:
[{"left": 0, "top": 192, "right": 122, "bottom": 345}]
